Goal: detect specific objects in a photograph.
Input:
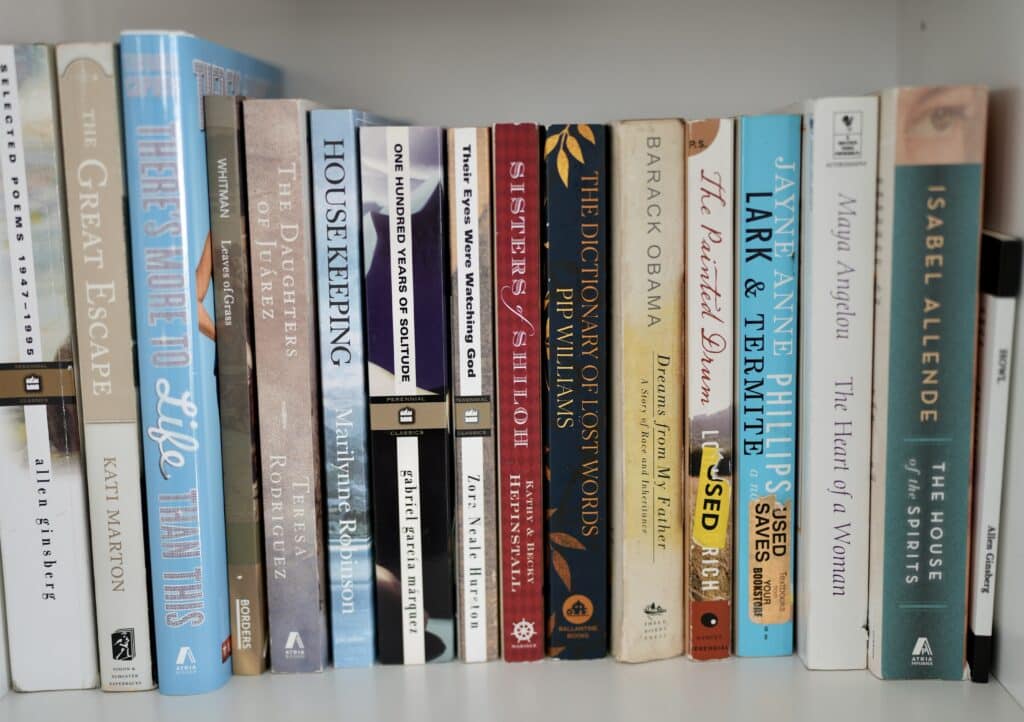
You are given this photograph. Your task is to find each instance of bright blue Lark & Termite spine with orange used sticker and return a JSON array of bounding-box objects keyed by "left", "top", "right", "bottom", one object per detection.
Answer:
[{"left": 734, "top": 116, "right": 801, "bottom": 656}]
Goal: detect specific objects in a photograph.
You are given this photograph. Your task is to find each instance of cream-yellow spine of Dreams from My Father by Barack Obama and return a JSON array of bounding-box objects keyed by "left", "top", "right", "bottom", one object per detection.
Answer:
[{"left": 608, "top": 120, "right": 688, "bottom": 662}]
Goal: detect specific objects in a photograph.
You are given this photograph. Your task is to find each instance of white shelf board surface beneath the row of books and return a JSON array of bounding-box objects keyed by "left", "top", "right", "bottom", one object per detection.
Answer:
[{"left": 0, "top": 657, "right": 1024, "bottom": 722}]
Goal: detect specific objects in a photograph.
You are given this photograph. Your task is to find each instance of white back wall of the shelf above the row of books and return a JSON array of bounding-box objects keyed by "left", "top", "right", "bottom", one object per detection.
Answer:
[{"left": 9, "top": 0, "right": 899, "bottom": 125}]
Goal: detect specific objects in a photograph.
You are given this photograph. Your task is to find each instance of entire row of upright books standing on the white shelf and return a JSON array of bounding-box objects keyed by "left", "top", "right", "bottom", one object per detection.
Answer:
[{"left": 0, "top": 33, "right": 1021, "bottom": 693}]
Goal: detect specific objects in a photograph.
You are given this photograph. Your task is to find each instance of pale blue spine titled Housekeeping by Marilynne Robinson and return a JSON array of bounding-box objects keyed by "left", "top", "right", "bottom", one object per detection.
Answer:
[{"left": 309, "top": 110, "right": 374, "bottom": 667}]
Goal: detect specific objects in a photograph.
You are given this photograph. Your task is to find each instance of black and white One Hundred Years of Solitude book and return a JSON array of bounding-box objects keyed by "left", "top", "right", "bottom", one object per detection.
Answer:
[{"left": 359, "top": 126, "right": 456, "bottom": 665}]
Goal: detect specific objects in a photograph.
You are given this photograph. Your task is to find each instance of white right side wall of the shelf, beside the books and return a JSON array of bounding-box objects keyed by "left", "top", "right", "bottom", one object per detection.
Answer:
[{"left": 902, "top": 0, "right": 1024, "bottom": 702}]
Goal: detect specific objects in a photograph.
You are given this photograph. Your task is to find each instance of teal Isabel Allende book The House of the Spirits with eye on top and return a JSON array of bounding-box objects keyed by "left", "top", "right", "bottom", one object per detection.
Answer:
[{"left": 867, "top": 85, "right": 987, "bottom": 679}]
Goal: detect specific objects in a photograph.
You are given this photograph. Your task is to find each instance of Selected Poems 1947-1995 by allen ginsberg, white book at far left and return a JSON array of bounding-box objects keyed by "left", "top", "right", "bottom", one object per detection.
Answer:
[{"left": 0, "top": 45, "right": 98, "bottom": 691}]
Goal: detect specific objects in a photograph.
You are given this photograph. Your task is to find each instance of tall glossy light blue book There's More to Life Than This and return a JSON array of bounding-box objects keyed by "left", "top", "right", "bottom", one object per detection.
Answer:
[{"left": 121, "top": 32, "right": 280, "bottom": 694}]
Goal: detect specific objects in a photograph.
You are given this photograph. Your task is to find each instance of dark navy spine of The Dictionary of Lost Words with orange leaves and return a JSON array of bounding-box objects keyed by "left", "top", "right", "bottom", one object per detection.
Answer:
[{"left": 544, "top": 124, "right": 608, "bottom": 660}]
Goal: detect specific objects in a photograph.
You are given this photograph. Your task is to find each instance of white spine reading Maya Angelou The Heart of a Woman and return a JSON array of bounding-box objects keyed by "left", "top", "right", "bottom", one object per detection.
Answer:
[{"left": 797, "top": 97, "right": 879, "bottom": 670}]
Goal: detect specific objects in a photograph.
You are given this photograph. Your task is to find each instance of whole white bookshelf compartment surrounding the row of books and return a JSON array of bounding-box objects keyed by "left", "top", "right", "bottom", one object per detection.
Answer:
[{"left": 0, "top": 0, "right": 1024, "bottom": 722}]
